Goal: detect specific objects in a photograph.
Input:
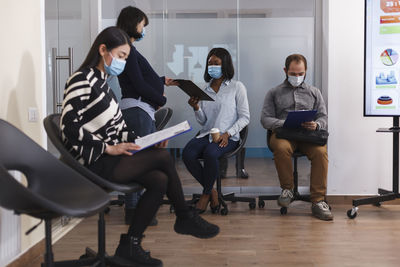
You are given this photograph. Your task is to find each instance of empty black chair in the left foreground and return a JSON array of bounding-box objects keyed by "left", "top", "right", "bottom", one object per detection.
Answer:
[{"left": 0, "top": 120, "right": 110, "bottom": 267}]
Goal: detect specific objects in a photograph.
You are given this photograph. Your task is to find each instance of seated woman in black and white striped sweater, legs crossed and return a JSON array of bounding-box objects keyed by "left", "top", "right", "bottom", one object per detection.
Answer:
[{"left": 60, "top": 27, "right": 219, "bottom": 266}]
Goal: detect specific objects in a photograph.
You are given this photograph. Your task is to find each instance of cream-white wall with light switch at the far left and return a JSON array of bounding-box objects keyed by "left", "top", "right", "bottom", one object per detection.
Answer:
[{"left": 0, "top": 0, "right": 46, "bottom": 262}]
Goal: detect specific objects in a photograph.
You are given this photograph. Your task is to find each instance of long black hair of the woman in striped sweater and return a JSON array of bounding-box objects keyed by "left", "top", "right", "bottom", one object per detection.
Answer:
[{"left": 78, "top": 26, "right": 129, "bottom": 71}]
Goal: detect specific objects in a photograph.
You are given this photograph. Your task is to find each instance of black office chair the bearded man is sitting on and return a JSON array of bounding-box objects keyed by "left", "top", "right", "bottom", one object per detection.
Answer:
[{"left": 258, "top": 130, "right": 310, "bottom": 215}]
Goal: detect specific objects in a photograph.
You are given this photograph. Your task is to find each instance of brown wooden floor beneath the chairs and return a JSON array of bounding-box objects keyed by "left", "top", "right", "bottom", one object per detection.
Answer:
[{"left": 28, "top": 159, "right": 400, "bottom": 267}]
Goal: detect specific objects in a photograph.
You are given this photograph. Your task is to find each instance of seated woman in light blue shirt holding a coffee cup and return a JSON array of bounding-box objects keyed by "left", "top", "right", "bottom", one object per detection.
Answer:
[{"left": 182, "top": 48, "right": 250, "bottom": 213}]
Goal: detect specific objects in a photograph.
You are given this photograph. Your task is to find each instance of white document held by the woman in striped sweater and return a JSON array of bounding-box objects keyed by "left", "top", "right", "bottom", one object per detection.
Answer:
[{"left": 135, "top": 121, "right": 192, "bottom": 152}]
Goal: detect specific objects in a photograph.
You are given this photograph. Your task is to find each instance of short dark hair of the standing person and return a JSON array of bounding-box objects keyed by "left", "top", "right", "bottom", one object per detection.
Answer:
[{"left": 117, "top": 6, "right": 149, "bottom": 39}]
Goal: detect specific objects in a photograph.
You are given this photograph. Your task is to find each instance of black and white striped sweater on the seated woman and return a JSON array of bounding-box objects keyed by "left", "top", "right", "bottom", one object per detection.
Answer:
[{"left": 60, "top": 68, "right": 136, "bottom": 165}]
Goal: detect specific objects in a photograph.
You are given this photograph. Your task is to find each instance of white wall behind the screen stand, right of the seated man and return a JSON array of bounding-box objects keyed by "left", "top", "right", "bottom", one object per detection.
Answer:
[{"left": 323, "top": 0, "right": 393, "bottom": 195}]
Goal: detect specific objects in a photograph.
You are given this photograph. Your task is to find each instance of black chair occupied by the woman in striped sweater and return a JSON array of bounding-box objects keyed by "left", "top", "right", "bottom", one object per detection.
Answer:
[{"left": 43, "top": 114, "right": 142, "bottom": 263}]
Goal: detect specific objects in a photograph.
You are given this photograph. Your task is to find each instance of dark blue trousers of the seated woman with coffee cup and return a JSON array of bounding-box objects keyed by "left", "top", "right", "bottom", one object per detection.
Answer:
[{"left": 182, "top": 135, "right": 239, "bottom": 194}]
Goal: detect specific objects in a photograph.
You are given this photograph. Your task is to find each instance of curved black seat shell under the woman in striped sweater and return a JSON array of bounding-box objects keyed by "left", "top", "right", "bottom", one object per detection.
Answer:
[{"left": 43, "top": 114, "right": 142, "bottom": 193}]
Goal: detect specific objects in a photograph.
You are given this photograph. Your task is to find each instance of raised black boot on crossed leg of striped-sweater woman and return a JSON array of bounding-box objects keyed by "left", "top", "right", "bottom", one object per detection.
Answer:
[{"left": 174, "top": 210, "right": 219, "bottom": 238}]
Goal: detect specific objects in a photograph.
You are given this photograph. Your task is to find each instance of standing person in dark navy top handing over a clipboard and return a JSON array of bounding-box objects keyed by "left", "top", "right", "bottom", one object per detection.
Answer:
[{"left": 117, "top": 6, "right": 176, "bottom": 225}]
